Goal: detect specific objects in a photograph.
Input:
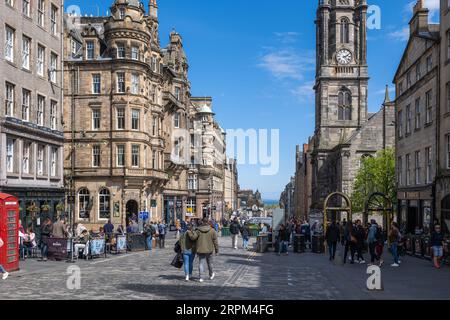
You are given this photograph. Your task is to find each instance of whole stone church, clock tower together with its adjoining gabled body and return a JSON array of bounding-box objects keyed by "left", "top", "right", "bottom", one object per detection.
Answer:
[{"left": 311, "top": 0, "right": 395, "bottom": 215}]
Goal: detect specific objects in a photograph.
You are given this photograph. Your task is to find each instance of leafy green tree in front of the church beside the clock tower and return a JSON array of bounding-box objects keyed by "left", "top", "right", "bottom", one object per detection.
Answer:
[{"left": 352, "top": 149, "right": 397, "bottom": 212}]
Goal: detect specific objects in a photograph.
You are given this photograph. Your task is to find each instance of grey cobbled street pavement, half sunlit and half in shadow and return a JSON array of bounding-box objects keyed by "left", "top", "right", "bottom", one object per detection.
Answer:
[{"left": 0, "top": 234, "right": 450, "bottom": 300}]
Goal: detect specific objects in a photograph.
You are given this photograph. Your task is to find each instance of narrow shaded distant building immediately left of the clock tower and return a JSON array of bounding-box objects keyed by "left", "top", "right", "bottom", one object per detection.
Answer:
[{"left": 294, "top": 143, "right": 312, "bottom": 220}]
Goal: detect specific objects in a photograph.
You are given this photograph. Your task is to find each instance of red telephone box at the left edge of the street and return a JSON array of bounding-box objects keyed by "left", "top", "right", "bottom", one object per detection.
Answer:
[{"left": 0, "top": 193, "right": 19, "bottom": 272}]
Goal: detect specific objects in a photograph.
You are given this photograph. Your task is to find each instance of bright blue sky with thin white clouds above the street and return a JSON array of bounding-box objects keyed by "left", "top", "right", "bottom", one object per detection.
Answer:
[{"left": 65, "top": 0, "right": 439, "bottom": 199}]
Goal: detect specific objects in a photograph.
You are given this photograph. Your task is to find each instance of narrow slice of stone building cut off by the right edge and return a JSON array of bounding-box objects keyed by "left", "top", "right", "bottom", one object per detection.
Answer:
[{"left": 436, "top": 0, "right": 450, "bottom": 232}]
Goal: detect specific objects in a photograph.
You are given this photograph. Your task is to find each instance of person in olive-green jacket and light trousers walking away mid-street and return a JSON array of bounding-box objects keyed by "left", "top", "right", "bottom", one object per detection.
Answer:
[{"left": 188, "top": 218, "right": 219, "bottom": 282}]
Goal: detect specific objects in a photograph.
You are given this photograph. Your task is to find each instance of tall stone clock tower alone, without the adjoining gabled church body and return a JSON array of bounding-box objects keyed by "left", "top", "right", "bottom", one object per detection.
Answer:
[{"left": 312, "top": 0, "right": 369, "bottom": 208}]
